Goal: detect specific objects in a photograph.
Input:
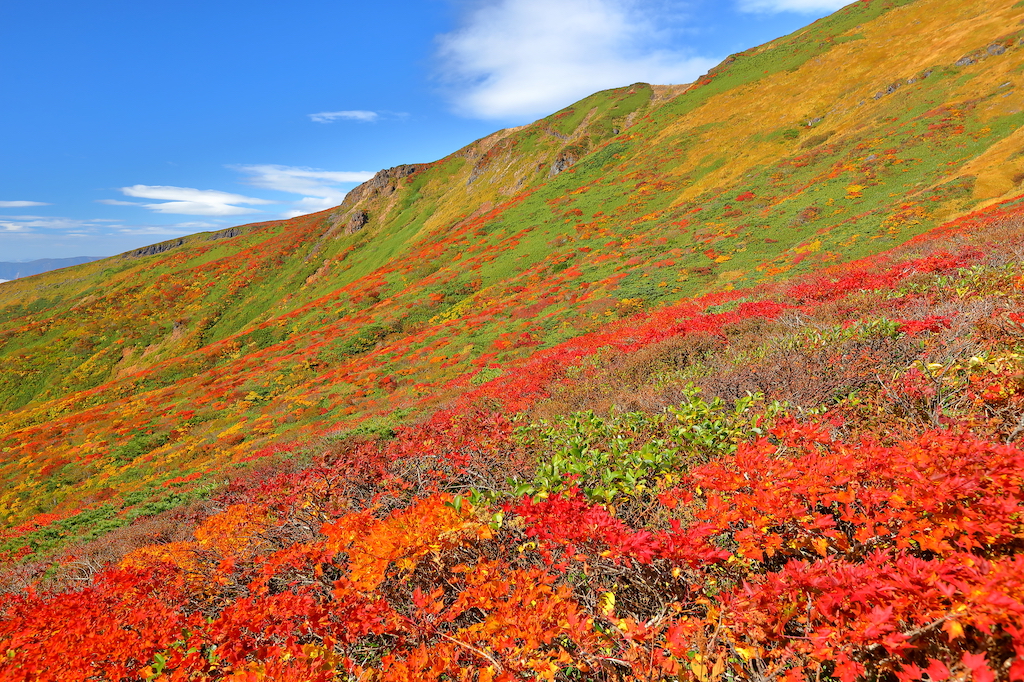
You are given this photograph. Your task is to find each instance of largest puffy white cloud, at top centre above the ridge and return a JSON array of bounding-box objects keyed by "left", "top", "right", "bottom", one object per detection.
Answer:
[{"left": 437, "top": 0, "right": 718, "bottom": 119}]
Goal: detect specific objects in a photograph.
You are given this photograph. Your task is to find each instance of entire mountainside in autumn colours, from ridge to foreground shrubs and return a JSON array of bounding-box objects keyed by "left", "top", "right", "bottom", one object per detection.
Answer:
[{"left": 0, "top": 0, "right": 1024, "bottom": 682}]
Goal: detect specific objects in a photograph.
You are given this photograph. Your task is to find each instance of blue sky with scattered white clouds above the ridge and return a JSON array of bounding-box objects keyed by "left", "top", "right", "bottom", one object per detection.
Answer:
[{"left": 0, "top": 0, "right": 846, "bottom": 261}]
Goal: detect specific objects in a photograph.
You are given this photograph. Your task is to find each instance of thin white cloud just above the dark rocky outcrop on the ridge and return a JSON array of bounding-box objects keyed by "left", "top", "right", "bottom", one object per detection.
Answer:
[{"left": 231, "top": 164, "right": 374, "bottom": 218}]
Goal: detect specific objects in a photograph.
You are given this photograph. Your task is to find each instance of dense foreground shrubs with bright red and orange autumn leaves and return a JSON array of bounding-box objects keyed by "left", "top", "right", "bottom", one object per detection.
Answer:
[{"left": 0, "top": 188, "right": 1024, "bottom": 682}]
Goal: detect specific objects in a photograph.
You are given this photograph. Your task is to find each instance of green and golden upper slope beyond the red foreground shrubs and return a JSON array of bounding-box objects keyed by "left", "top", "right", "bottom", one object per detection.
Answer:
[{"left": 0, "top": 0, "right": 1024, "bottom": 551}]
